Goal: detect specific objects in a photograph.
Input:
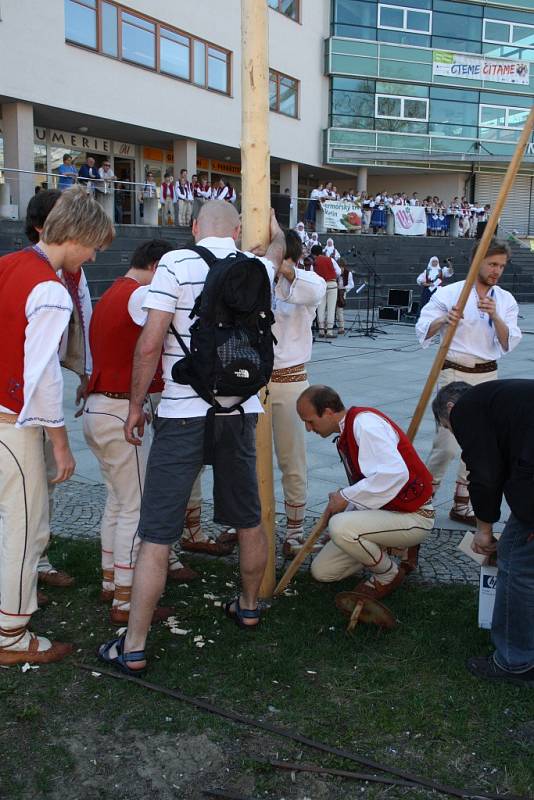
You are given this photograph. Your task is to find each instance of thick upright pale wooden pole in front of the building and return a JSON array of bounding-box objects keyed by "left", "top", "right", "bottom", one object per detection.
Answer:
[{"left": 241, "top": 0, "right": 276, "bottom": 597}]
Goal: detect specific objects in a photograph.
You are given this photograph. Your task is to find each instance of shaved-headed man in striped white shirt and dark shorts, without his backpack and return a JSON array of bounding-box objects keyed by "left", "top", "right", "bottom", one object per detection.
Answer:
[{"left": 100, "top": 200, "right": 285, "bottom": 674}]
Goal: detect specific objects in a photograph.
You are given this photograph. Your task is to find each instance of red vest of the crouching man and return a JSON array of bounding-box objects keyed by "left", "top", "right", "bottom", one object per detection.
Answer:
[{"left": 337, "top": 406, "right": 432, "bottom": 512}]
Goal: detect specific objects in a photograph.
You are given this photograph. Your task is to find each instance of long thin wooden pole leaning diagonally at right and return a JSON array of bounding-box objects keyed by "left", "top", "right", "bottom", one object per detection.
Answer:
[{"left": 408, "top": 106, "right": 534, "bottom": 442}]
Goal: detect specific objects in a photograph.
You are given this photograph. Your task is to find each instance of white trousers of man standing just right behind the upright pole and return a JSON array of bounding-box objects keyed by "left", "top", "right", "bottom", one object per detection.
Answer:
[{"left": 269, "top": 381, "right": 309, "bottom": 531}]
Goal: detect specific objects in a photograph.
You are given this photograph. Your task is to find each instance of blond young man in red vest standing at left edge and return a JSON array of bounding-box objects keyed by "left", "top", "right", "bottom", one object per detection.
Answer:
[{"left": 0, "top": 187, "right": 114, "bottom": 666}]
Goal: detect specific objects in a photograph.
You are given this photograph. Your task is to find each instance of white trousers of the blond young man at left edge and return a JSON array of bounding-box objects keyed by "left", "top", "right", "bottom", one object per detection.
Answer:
[{"left": 0, "top": 422, "right": 49, "bottom": 628}]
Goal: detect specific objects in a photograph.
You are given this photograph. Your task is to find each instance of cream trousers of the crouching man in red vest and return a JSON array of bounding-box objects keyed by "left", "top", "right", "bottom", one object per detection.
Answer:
[{"left": 311, "top": 509, "right": 434, "bottom": 582}]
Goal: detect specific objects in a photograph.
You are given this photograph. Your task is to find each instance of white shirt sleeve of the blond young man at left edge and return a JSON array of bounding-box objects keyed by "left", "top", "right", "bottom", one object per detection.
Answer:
[{"left": 0, "top": 281, "right": 72, "bottom": 428}]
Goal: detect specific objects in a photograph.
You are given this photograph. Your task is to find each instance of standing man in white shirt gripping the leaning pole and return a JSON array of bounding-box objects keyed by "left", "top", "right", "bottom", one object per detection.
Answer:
[{"left": 416, "top": 239, "right": 521, "bottom": 525}]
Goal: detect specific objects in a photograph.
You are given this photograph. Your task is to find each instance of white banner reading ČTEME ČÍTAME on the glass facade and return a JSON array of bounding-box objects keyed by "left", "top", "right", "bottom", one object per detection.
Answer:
[{"left": 432, "top": 50, "right": 530, "bottom": 86}]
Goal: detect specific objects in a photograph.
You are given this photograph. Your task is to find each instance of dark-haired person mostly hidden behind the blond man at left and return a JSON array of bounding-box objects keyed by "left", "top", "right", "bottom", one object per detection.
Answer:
[{"left": 25, "top": 189, "right": 93, "bottom": 599}]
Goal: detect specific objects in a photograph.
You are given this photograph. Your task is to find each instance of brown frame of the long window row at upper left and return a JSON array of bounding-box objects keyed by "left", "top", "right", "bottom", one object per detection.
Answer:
[{"left": 65, "top": 0, "right": 232, "bottom": 97}]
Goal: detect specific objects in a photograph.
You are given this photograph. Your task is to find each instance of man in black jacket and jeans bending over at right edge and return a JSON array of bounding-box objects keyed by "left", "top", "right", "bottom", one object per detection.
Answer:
[{"left": 432, "top": 380, "right": 534, "bottom": 687}]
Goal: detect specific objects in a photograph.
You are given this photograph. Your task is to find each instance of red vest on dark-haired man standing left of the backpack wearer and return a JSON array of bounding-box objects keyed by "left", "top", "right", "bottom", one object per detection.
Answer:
[{"left": 87, "top": 278, "right": 163, "bottom": 394}]
